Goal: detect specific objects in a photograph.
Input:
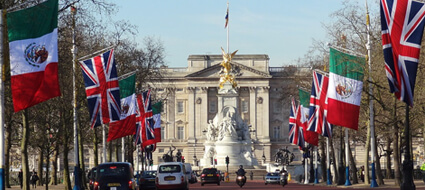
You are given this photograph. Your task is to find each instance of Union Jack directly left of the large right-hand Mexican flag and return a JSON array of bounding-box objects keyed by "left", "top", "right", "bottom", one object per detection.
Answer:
[{"left": 307, "top": 71, "right": 332, "bottom": 137}]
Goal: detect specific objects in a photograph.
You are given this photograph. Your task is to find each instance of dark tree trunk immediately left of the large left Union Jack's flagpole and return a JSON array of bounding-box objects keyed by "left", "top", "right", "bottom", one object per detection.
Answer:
[{"left": 62, "top": 111, "right": 72, "bottom": 190}]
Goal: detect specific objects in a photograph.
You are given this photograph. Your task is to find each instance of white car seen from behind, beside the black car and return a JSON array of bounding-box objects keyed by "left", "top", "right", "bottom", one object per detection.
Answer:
[{"left": 155, "top": 162, "right": 189, "bottom": 190}]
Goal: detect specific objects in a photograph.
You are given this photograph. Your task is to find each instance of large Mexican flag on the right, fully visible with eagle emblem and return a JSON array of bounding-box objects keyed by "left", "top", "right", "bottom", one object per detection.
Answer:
[{"left": 328, "top": 48, "right": 366, "bottom": 130}]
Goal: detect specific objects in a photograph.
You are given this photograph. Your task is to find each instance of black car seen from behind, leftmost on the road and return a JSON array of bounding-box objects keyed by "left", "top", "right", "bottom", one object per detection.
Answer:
[{"left": 93, "top": 162, "right": 138, "bottom": 190}]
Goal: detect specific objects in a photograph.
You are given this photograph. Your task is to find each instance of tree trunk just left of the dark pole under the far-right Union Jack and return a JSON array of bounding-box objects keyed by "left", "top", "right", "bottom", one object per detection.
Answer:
[{"left": 393, "top": 98, "right": 401, "bottom": 186}]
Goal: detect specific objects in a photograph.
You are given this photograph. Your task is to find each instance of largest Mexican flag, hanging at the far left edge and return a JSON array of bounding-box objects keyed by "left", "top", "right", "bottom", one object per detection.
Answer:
[{"left": 7, "top": 0, "right": 61, "bottom": 112}]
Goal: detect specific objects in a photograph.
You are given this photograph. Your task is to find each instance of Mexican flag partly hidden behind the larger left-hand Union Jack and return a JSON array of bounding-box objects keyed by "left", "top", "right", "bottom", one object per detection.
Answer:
[{"left": 107, "top": 74, "right": 137, "bottom": 142}]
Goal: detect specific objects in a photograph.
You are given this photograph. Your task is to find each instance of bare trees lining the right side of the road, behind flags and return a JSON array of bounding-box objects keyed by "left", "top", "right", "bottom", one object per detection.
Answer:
[{"left": 282, "top": 1, "right": 425, "bottom": 185}]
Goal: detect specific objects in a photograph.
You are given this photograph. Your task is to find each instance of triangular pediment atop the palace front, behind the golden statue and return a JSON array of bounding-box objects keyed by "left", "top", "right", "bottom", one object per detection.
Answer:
[{"left": 185, "top": 61, "right": 272, "bottom": 79}]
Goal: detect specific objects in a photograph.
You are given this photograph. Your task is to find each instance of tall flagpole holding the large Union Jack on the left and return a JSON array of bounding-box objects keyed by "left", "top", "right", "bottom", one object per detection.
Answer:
[{"left": 71, "top": 6, "right": 80, "bottom": 190}]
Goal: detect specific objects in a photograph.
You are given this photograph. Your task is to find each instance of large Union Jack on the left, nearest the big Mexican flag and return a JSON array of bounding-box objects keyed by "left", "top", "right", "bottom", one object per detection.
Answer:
[{"left": 80, "top": 49, "right": 121, "bottom": 128}]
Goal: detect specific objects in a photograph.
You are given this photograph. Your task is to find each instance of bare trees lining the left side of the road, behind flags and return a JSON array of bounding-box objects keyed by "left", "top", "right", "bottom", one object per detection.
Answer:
[{"left": 0, "top": 0, "right": 164, "bottom": 190}]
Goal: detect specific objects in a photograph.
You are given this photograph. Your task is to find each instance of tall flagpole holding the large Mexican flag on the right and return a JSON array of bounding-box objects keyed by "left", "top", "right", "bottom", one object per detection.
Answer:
[{"left": 365, "top": 0, "right": 378, "bottom": 187}]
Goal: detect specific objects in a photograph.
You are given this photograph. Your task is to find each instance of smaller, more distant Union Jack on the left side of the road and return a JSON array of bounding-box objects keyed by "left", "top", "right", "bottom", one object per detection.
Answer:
[{"left": 136, "top": 90, "right": 155, "bottom": 147}]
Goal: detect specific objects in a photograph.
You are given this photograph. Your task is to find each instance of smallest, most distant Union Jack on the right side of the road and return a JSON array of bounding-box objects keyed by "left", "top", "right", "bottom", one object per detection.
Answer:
[{"left": 289, "top": 98, "right": 304, "bottom": 148}]
